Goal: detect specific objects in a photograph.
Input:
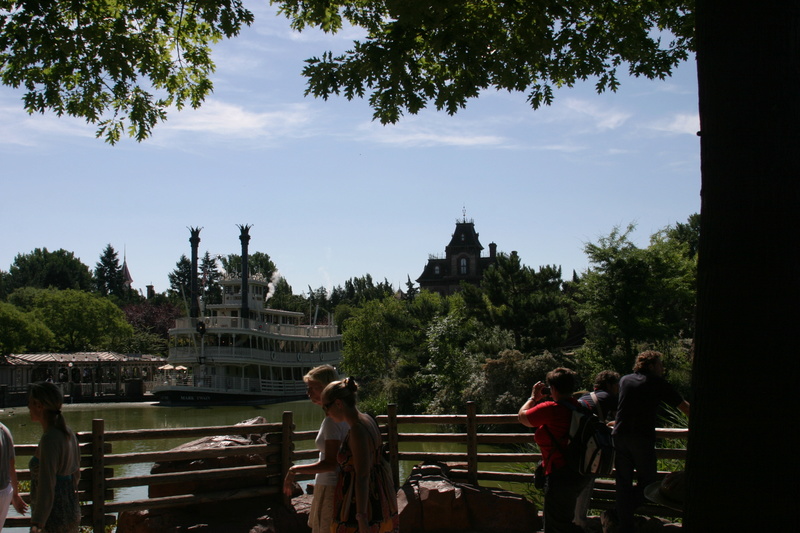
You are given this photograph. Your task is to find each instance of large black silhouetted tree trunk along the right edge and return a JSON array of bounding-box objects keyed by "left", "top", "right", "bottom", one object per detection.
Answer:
[{"left": 684, "top": 0, "right": 800, "bottom": 532}]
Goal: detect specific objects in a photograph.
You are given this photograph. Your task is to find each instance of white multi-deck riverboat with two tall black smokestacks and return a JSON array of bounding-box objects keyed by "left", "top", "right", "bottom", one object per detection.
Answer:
[{"left": 153, "top": 226, "right": 342, "bottom": 405}]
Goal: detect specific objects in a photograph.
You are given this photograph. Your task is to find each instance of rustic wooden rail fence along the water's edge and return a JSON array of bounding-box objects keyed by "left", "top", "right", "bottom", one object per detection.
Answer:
[{"left": 6, "top": 403, "right": 687, "bottom": 532}]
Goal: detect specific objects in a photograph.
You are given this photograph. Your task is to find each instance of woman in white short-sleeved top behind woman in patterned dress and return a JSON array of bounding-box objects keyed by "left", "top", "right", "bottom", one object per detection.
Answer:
[{"left": 283, "top": 365, "right": 349, "bottom": 533}]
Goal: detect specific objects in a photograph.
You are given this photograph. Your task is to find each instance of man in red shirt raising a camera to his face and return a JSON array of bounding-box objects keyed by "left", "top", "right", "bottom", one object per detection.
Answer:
[{"left": 518, "top": 367, "right": 588, "bottom": 533}]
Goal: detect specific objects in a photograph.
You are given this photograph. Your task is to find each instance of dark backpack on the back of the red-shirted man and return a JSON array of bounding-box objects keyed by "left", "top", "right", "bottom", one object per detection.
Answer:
[{"left": 555, "top": 402, "right": 614, "bottom": 477}]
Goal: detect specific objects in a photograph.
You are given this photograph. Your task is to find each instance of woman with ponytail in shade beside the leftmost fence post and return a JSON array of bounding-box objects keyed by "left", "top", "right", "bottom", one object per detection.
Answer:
[{"left": 28, "top": 382, "right": 81, "bottom": 533}]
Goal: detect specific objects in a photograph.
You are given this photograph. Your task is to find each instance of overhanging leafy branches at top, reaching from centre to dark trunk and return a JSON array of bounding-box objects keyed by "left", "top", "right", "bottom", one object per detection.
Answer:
[{"left": 274, "top": 0, "right": 694, "bottom": 123}]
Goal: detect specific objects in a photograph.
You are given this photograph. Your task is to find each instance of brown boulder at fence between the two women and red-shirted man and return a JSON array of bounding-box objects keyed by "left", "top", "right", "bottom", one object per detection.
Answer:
[{"left": 397, "top": 463, "right": 542, "bottom": 533}]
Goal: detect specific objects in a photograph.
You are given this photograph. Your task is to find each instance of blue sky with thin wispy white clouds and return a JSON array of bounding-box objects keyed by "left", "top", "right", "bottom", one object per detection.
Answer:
[{"left": 0, "top": 1, "right": 700, "bottom": 294}]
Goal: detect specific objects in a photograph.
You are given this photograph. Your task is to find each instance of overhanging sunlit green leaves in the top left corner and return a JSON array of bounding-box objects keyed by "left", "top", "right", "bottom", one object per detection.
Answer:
[{"left": 0, "top": 0, "right": 253, "bottom": 144}]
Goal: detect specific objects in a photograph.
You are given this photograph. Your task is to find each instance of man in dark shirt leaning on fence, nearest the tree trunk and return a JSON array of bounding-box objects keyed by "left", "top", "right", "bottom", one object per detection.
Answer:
[{"left": 613, "top": 350, "right": 689, "bottom": 533}]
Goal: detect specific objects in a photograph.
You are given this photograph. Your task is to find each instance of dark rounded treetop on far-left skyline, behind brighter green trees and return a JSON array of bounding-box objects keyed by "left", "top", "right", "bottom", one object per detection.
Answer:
[{"left": 6, "top": 248, "right": 94, "bottom": 293}]
